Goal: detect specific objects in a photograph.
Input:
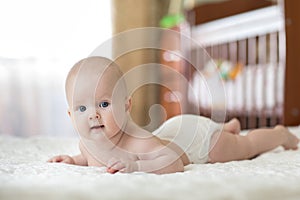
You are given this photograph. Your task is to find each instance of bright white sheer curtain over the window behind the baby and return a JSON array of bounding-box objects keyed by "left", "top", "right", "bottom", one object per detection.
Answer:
[{"left": 0, "top": 0, "right": 111, "bottom": 136}]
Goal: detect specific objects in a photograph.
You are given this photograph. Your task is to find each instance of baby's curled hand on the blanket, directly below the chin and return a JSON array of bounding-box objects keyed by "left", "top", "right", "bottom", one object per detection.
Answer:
[{"left": 106, "top": 158, "right": 138, "bottom": 174}]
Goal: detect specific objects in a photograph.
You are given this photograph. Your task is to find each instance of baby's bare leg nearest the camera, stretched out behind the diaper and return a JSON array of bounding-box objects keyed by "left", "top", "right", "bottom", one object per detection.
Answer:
[{"left": 209, "top": 126, "right": 299, "bottom": 163}]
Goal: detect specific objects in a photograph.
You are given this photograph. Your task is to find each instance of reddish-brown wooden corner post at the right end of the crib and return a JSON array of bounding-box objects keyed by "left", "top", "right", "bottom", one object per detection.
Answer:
[{"left": 283, "top": 0, "right": 300, "bottom": 126}]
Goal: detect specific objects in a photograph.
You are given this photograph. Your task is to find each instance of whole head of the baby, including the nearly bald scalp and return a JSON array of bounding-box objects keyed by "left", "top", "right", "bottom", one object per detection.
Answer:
[{"left": 65, "top": 57, "right": 131, "bottom": 140}]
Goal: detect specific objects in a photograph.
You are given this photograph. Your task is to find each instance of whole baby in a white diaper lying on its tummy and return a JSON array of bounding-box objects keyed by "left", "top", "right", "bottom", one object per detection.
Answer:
[{"left": 49, "top": 57, "right": 299, "bottom": 174}]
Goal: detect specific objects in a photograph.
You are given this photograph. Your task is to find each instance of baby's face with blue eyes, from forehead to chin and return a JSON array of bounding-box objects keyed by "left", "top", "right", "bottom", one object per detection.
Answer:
[{"left": 69, "top": 59, "right": 128, "bottom": 140}]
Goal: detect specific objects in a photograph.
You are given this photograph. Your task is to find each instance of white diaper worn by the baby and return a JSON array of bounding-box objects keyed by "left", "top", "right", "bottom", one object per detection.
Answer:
[{"left": 153, "top": 115, "right": 222, "bottom": 164}]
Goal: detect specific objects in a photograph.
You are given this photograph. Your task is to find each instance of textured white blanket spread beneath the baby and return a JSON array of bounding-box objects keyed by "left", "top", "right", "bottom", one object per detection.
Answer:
[{"left": 0, "top": 127, "right": 300, "bottom": 200}]
